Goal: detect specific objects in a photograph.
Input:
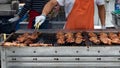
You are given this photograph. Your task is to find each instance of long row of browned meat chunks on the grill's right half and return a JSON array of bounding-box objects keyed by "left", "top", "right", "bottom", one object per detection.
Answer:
[{"left": 56, "top": 32, "right": 120, "bottom": 45}]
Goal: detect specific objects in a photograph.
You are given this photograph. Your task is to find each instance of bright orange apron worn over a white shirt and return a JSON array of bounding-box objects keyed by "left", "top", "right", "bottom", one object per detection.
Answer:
[{"left": 65, "top": 0, "right": 94, "bottom": 30}]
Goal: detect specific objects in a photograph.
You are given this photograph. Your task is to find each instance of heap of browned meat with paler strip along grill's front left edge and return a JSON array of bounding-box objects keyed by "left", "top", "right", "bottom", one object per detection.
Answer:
[{"left": 2, "top": 32, "right": 52, "bottom": 47}]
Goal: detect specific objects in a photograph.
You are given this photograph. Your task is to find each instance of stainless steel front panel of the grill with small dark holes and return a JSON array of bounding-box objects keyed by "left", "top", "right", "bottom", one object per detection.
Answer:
[{"left": 1, "top": 46, "right": 120, "bottom": 68}]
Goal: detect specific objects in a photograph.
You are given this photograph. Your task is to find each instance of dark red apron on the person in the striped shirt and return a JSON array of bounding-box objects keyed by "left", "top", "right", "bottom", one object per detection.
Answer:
[{"left": 28, "top": 10, "right": 40, "bottom": 29}]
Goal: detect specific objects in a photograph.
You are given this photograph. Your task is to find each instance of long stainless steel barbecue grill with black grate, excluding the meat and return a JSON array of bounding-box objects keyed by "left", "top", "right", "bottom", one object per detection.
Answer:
[{"left": 1, "top": 29, "right": 120, "bottom": 68}]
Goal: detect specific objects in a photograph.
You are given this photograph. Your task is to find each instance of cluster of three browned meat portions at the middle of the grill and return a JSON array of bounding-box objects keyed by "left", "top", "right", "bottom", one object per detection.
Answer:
[{"left": 56, "top": 32, "right": 83, "bottom": 44}]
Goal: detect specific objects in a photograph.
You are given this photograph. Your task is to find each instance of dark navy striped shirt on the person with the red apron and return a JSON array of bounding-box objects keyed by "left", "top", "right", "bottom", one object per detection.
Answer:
[{"left": 18, "top": 0, "right": 48, "bottom": 17}]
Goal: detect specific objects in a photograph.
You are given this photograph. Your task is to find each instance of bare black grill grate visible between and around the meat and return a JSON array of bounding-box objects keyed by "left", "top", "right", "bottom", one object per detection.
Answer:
[{"left": 6, "top": 32, "right": 119, "bottom": 46}]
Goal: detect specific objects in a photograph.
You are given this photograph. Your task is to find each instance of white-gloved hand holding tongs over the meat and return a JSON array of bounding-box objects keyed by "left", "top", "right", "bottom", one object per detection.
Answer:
[{"left": 34, "top": 15, "right": 46, "bottom": 29}]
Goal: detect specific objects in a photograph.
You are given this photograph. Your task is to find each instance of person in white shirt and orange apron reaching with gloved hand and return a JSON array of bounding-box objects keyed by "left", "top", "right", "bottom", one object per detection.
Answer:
[{"left": 34, "top": 0, "right": 105, "bottom": 30}]
